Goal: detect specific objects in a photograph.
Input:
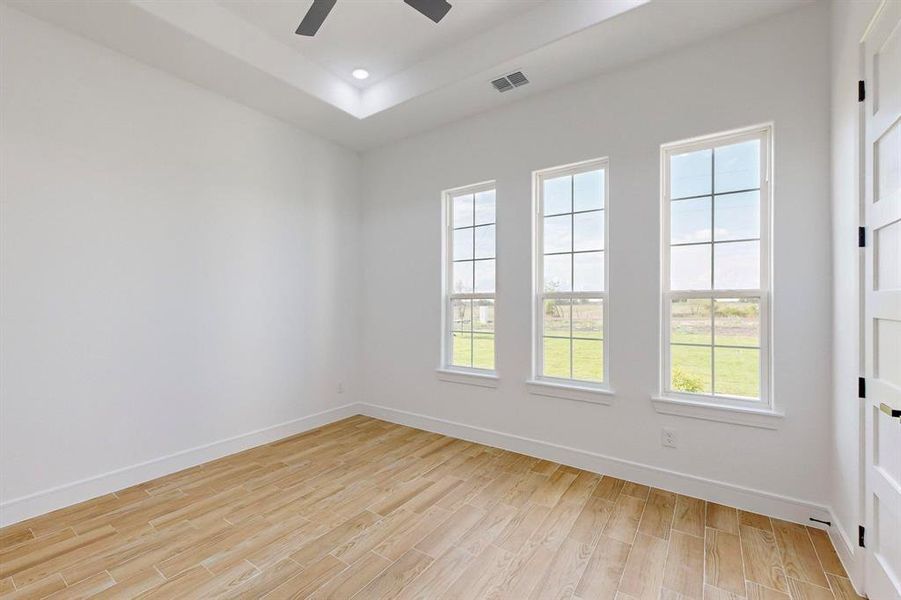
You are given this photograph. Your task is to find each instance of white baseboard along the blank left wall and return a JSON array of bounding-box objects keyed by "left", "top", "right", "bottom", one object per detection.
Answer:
[{"left": 0, "top": 403, "right": 359, "bottom": 527}]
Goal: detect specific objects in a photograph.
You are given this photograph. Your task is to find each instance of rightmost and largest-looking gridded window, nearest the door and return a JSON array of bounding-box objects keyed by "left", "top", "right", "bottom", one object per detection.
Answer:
[{"left": 661, "top": 126, "right": 772, "bottom": 405}]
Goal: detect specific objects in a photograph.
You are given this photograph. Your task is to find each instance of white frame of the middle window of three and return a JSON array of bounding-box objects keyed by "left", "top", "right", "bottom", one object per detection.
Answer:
[{"left": 529, "top": 156, "right": 612, "bottom": 392}]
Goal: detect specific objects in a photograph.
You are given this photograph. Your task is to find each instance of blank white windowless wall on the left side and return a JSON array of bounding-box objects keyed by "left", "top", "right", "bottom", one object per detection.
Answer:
[{"left": 0, "top": 5, "right": 361, "bottom": 522}]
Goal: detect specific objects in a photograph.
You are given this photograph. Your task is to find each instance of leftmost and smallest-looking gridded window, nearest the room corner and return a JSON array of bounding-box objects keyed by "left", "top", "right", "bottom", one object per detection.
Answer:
[{"left": 442, "top": 182, "right": 495, "bottom": 371}]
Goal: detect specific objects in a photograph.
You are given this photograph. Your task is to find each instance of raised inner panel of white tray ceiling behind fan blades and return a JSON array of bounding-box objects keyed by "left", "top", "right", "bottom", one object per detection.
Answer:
[{"left": 217, "top": 0, "right": 545, "bottom": 88}]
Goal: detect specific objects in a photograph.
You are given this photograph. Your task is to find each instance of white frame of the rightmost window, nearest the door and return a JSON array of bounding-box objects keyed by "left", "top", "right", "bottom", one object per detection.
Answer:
[{"left": 660, "top": 123, "right": 773, "bottom": 411}]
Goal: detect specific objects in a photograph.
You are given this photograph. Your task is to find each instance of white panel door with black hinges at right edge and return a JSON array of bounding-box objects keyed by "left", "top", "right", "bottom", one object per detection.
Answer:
[{"left": 863, "top": 0, "right": 901, "bottom": 600}]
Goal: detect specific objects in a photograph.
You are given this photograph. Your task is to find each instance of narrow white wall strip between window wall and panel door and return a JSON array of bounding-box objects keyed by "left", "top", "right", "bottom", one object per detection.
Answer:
[{"left": 829, "top": 0, "right": 879, "bottom": 584}]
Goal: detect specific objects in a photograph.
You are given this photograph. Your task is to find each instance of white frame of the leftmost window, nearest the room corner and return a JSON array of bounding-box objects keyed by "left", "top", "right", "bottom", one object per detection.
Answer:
[{"left": 438, "top": 180, "right": 498, "bottom": 376}]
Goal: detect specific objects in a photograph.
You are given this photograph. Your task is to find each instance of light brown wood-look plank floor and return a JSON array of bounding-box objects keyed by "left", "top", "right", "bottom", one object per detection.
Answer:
[{"left": 0, "top": 416, "right": 857, "bottom": 600}]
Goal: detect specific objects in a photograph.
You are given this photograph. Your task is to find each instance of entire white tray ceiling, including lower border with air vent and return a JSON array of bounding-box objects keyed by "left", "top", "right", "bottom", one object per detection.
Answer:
[{"left": 4, "top": 0, "right": 813, "bottom": 150}]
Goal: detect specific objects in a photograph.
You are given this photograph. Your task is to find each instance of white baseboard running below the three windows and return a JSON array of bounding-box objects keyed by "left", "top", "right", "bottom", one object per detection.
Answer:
[{"left": 358, "top": 403, "right": 830, "bottom": 527}]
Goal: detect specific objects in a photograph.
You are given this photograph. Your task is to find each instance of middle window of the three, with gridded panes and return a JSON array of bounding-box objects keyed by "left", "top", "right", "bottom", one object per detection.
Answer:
[{"left": 534, "top": 160, "right": 608, "bottom": 386}]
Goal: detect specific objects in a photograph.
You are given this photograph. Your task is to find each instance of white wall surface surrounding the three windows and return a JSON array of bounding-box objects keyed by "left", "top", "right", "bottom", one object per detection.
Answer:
[{"left": 363, "top": 3, "right": 832, "bottom": 520}]
